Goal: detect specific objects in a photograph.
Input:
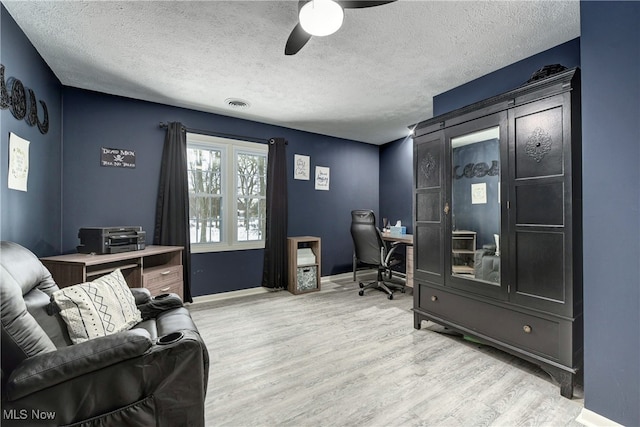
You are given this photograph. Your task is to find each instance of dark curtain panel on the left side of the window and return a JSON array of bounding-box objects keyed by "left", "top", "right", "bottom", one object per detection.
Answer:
[{"left": 153, "top": 122, "right": 193, "bottom": 302}]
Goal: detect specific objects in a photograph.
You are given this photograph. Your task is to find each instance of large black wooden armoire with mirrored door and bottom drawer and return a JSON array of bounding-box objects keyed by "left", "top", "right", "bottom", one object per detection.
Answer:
[{"left": 413, "top": 69, "right": 583, "bottom": 398}]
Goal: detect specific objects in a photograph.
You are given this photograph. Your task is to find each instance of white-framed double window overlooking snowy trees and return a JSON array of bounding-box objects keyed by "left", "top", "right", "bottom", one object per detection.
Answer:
[{"left": 187, "top": 133, "right": 268, "bottom": 252}]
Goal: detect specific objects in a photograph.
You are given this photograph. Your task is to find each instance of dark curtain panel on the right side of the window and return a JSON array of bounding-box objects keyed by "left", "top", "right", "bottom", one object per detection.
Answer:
[{"left": 262, "top": 138, "right": 287, "bottom": 289}]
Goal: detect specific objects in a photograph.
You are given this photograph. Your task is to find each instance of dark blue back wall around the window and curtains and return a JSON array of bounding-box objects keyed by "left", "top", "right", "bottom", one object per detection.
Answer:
[{"left": 62, "top": 87, "right": 379, "bottom": 296}]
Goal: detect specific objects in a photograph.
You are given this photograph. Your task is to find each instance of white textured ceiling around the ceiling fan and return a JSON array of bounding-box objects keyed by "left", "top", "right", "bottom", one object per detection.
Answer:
[{"left": 2, "top": 0, "right": 580, "bottom": 144}]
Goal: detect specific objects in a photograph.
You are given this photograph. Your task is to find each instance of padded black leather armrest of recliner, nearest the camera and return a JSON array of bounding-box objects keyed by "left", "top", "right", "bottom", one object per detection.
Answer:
[{"left": 6, "top": 329, "right": 153, "bottom": 400}]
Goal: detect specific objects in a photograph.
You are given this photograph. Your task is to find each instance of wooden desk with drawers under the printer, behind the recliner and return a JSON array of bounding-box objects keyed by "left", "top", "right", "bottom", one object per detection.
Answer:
[{"left": 41, "top": 246, "right": 183, "bottom": 298}]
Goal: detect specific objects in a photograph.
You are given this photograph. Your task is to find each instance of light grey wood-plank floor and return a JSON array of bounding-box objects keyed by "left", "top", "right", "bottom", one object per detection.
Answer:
[{"left": 189, "top": 275, "right": 583, "bottom": 427}]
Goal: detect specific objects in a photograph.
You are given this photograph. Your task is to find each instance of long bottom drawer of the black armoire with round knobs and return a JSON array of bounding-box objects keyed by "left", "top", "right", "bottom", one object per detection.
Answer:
[{"left": 420, "top": 286, "right": 560, "bottom": 360}]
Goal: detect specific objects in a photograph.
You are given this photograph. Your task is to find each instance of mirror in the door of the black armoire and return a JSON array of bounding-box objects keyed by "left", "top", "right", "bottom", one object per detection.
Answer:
[{"left": 445, "top": 114, "right": 507, "bottom": 298}]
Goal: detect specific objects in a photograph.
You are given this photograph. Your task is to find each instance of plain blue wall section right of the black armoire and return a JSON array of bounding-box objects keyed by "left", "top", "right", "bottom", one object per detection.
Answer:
[{"left": 580, "top": 1, "right": 640, "bottom": 426}]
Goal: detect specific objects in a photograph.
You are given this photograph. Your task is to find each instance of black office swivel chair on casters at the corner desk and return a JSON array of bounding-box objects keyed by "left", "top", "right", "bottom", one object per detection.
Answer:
[{"left": 351, "top": 210, "right": 405, "bottom": 299}]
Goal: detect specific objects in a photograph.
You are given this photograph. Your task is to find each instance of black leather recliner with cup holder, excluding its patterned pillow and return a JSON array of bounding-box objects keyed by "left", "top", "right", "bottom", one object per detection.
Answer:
[{"left": 0, "top": 242, "right": 209, "bottom": 427}]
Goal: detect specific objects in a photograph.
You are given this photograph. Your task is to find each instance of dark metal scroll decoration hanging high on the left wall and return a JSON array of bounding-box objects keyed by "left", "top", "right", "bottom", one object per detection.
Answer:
[{"left": 0, "top": 64, "right": 49, "bottom": 135}]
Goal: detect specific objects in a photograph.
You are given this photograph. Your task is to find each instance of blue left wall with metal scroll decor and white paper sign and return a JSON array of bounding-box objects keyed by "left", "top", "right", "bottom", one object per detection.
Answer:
[{"left": 0, "top": 5, "right": 62, "bottom": 256}]
